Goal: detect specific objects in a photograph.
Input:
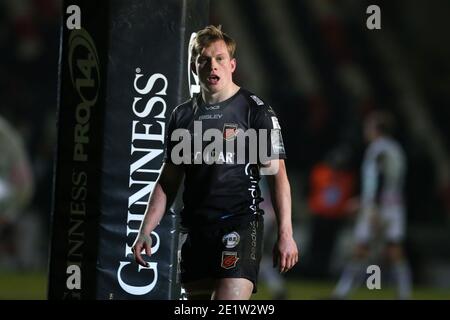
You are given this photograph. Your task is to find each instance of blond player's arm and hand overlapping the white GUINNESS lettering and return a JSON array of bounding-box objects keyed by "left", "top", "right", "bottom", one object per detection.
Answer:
[{"left": 132, "top": 163, "right": 184, "bottom": 267}]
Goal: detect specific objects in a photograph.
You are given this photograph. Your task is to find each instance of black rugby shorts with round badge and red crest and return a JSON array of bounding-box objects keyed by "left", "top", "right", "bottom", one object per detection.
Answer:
[{"left": 180, "top": 215, "right": 264, "bottom": 293}]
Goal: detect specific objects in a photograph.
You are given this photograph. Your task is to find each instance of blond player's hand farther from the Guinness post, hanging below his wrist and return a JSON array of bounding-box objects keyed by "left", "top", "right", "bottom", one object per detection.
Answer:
[{"left": 273, "top": 236, "right": 298, "bottom": 273}]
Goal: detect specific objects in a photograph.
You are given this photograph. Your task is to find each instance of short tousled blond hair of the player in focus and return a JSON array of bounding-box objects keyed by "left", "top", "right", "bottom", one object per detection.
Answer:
[{"left": 190, "top": 25, "right": 236, "bottom": 61}]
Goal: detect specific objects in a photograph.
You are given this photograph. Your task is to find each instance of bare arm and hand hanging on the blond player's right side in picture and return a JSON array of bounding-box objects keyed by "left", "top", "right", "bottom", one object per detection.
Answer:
[{"left": 267, "top": 159, "right": 299, "bottom": 273}]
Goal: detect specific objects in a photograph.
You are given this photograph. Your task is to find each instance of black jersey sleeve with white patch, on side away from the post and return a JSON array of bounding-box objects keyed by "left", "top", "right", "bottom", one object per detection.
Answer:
[{"left": 250, "top": 103, "right": 286, "bottom": 159}]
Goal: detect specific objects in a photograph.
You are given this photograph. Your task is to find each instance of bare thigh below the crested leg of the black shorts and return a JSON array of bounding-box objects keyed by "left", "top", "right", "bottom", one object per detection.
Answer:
[{"left": 212, "top": 278, "right": 253, "bottom": 300}]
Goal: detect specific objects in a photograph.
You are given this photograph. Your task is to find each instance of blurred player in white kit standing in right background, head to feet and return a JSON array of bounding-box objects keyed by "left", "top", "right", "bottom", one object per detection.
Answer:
[{"left": 333, "top": 111, "right": 412, "bottom": 299}]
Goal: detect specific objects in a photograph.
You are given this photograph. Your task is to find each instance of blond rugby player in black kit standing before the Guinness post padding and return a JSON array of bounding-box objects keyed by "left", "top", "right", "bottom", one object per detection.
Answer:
[{"left": 133, "top": 26, "right": 298, "bottom": 300}]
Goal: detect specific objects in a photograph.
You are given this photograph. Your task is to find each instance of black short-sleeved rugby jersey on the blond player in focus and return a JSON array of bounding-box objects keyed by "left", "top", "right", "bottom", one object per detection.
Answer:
[{"left": 165, "top": 88, "right": 286, "bottom": 228}]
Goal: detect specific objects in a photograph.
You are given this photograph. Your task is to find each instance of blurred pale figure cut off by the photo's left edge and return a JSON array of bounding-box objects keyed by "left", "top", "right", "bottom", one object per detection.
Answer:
[{"left": 0, "top": 116, "right": 34, "bottom": 270}]
